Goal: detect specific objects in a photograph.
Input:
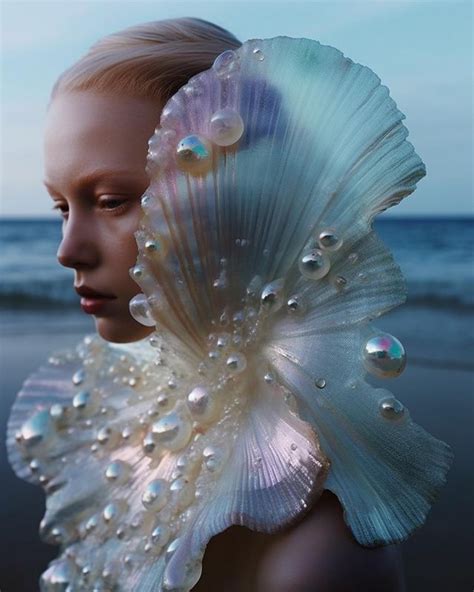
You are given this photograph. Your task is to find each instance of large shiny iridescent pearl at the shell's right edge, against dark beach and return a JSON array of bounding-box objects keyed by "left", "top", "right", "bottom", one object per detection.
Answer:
[{"left": 363, "top": 333, "right": 406, "bottom": 378}]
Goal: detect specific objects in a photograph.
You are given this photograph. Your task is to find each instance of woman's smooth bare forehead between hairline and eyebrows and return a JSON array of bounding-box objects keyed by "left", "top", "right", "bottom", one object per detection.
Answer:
[{"left": 44, "top": 91, "right": 160, "bottom": 184}]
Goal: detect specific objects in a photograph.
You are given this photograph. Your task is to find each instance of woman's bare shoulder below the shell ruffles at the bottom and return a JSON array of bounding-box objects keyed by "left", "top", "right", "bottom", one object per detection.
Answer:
[{"left": 257, "top": 492, "right": 404, "bottom": 592}]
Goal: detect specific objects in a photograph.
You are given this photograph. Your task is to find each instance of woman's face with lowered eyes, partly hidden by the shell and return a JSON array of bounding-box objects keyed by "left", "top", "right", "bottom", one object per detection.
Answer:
[{"left": 44, "top": 91, "right": 160, "bottom": 343}]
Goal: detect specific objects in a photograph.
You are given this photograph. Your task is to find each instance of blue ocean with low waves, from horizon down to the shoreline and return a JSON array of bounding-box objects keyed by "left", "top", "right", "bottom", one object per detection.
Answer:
[{"left": 0, "top": 218, "right": 474, "bottom": 311}]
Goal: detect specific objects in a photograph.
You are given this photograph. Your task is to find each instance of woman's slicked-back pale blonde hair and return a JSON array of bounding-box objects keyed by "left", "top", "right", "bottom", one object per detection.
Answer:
[{"left": 50, "top": 18, "right": 241, "bottom": 105}]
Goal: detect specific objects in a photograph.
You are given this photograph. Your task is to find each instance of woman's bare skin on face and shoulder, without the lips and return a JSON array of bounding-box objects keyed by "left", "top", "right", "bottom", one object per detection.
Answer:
[{"left": 44, "top": 91, "right": 404, "bottom": 592}]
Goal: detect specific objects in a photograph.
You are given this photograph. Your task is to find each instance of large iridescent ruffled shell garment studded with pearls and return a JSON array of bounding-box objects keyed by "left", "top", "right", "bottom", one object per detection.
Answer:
[{"left": 8, "top": 37, "right": 451, "bottom": 592}]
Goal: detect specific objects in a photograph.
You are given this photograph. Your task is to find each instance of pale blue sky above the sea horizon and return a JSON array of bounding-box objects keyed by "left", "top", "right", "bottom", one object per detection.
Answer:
[{"left": 0, "top": 0, "right": 474, "bottom": 217}]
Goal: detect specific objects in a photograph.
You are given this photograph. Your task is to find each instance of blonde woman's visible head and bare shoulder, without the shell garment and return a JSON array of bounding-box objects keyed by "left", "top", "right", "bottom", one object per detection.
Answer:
[{"left": 9, "top": 19, "right": 450, "bottom": 592}]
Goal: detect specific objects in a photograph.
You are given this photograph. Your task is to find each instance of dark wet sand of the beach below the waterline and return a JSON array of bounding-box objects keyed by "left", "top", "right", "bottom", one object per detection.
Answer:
[{"left": 0, "top": 307, "right": 474, "bottom": 592}]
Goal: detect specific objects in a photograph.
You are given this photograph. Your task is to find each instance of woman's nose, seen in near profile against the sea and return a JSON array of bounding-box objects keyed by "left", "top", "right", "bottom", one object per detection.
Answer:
[{"left": 56, "top": 212, "right": 100, "bottom": 269}]
